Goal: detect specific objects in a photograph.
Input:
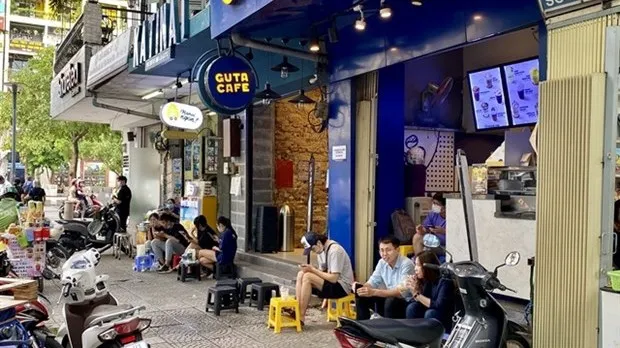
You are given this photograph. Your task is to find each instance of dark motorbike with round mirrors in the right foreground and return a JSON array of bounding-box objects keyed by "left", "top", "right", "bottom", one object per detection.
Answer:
[{"left": 334, "top": 235, "right": 530, "bottom": 348}]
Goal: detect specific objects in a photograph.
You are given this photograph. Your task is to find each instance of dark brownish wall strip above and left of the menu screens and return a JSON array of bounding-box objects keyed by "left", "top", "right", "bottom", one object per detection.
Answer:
[{"left": 463, "top": 27, "right": 538, "bottom": 133}]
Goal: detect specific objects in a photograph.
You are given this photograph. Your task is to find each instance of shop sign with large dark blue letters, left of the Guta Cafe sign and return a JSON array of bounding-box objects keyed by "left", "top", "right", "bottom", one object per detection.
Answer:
[{"left": 132, "top": 0, "right": 189, "bottom": 70}]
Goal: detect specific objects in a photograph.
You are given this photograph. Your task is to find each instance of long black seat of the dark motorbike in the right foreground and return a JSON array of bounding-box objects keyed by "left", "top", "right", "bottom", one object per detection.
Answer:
[{"left": 340, "top": 318, "right": 444, "bottom": 347}]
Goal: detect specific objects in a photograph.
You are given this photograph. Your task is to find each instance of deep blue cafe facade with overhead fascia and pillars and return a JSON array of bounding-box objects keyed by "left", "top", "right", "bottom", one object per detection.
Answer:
[{"left": 211, "top": 0, "right": 546, "bottom": 262}]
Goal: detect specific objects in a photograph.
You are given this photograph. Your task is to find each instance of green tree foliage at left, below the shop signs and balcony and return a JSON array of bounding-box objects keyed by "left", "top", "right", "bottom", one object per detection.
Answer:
[{"left": 0, "top": 47, "right": 120, "bottom": 177}]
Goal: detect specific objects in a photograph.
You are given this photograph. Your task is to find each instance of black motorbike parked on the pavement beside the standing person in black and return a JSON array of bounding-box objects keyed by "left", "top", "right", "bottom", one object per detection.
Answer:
[{"left": 57, "top": 204, "right": 120, "bottom": 255}]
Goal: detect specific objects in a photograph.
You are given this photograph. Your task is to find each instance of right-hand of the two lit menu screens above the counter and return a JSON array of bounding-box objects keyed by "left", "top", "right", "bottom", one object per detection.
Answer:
[{"left": 504, "top": 59, "right": 539, "bottom": 126}]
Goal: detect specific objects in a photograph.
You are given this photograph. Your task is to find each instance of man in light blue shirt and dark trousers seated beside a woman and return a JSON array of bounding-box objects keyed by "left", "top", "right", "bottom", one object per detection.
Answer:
[{"left": 353, "top": 236, "right": 414, "bottom": 320}]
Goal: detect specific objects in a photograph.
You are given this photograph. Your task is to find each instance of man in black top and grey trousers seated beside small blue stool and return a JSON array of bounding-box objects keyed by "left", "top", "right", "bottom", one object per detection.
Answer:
[{"left": 151, "top": 213, "right": 189, "bottom": 273}]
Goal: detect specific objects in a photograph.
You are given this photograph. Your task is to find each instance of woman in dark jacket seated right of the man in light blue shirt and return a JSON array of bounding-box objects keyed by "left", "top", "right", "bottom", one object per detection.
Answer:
[{"left": 406, "top": 251, "right": 456, "bottom": 332}]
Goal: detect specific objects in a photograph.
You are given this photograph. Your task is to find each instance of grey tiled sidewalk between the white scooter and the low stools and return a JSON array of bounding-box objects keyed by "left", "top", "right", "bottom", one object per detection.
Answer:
[{"left": 44, "top": 255, "right": 338, "bottom": 348}]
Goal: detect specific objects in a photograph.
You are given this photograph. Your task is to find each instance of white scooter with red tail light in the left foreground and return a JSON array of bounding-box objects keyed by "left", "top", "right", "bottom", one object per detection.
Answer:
[{"left": 56, "top": 249, "right": 151, "bottom": 348}]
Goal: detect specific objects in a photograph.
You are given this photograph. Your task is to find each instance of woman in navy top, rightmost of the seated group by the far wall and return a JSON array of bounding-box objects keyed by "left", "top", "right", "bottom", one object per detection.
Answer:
[{"left": 199, "top": 216, "right": 237, "bottom": 271}]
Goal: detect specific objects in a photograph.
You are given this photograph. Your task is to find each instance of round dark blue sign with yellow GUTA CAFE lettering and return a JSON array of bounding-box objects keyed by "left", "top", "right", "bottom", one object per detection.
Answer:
[{"left": 198, "top": 56, "right": 256, "bottom": 115}]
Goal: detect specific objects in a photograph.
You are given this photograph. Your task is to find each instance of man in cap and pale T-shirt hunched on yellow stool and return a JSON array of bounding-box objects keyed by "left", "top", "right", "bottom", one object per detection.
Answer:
[{"left": 288, "top": 232, "right": 353, "bottom": 323}]
